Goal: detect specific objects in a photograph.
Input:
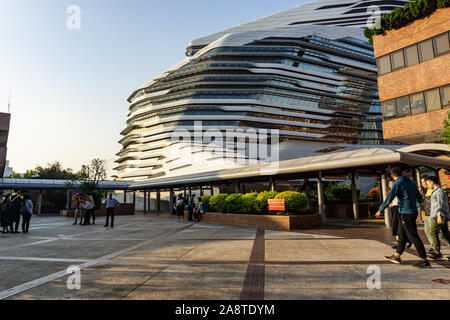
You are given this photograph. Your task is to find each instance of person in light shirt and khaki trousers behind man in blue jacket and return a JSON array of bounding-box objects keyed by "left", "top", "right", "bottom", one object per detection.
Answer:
[{"left": 425, "top": 176, "right": 450, "bottom": 260}]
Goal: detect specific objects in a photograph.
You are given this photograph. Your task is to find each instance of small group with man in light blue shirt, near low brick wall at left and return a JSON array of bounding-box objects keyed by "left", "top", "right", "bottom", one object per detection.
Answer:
[{"left": 72, "top": 193, "right": 119, "bottom": 228}]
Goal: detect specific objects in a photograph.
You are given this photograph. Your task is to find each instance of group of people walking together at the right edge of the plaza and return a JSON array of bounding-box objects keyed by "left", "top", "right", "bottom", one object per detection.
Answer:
[{"left": 376, "top": 167, "right": 450, "bottom": 268}]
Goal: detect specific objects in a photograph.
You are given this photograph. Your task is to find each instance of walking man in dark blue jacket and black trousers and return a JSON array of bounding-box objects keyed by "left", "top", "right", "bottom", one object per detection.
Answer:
[{"left": 376, "top": 167, "right": 431, "bottom": 268}]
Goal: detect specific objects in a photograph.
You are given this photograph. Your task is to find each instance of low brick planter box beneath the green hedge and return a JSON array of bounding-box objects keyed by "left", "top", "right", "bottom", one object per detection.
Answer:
[{"left": 196, "top": 212, "right": 322, "bottom": 231}]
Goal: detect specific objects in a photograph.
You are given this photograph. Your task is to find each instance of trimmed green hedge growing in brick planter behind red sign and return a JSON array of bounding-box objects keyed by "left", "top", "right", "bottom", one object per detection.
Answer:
[{"left": 202, "top": 191, "right": 308, "bottom": 214}]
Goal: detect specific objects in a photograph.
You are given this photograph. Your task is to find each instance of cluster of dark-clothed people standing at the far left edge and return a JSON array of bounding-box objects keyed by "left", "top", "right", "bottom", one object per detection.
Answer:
[{"left": 0, "top": 189, "right": 33, "bottom": 233}]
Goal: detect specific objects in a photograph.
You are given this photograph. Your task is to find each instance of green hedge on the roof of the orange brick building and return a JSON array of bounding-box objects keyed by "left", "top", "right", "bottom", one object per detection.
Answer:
[{"left": 364, "top": 0, "right": 450, "bottom": 44}]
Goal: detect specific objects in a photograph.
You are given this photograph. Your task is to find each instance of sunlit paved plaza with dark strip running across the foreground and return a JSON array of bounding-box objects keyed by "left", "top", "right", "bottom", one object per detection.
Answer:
[{"left": 0, "top": 216, "right": 450, "bottom": 300}]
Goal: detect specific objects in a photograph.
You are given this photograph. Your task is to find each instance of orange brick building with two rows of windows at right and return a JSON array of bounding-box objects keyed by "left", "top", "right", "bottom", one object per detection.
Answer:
[{"left": 373, "top": 8, "right": 450, "bottom": 144}]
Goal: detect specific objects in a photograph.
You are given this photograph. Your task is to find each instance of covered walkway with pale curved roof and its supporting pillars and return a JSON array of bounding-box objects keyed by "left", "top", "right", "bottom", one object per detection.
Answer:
[{"left": 130, "top": 144, "right": 450, "bottom": 227}]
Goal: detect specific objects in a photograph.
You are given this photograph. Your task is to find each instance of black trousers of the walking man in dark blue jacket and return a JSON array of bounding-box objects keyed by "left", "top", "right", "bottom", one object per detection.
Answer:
[{"left": 397, "top": 213, "right": 427, "bottom": 259}]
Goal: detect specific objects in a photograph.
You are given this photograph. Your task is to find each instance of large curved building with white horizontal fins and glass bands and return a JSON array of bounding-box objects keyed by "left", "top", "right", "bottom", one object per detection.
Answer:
[{"left": 115, "top": 0, "right": 405, "bottom": 181}]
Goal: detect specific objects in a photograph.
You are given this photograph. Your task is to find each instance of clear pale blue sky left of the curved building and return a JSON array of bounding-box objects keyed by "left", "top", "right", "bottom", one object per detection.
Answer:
[{"left": 0, "top": 0, "right": 306, "bottom": 176}]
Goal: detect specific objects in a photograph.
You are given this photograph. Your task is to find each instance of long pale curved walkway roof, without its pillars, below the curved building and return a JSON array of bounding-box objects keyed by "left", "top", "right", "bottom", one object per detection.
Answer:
[{"left": 130, "top": 144, "right": 450, "bottom": 189}]
